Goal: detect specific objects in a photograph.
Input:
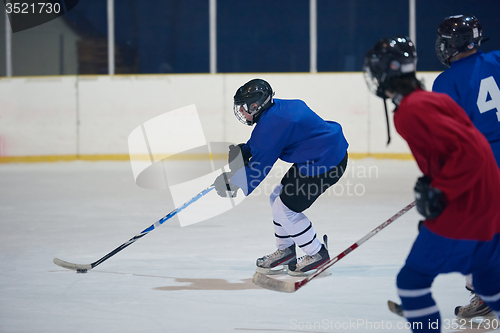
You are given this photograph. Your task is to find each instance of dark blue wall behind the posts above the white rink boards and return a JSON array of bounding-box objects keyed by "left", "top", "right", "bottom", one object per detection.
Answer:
[{"left": 66, "top": 0, "right": 500, "bottom": 73}]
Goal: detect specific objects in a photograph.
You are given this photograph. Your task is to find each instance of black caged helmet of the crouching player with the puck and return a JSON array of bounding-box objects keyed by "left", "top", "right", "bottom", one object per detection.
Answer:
[{"left": 233, "top": 79, "right": 274, "bottom": 126}]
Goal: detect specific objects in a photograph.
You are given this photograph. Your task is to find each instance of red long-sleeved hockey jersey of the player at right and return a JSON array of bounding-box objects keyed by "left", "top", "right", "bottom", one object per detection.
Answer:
[{"left": 394, "top": 89, "right": 500, "bottom": 241}]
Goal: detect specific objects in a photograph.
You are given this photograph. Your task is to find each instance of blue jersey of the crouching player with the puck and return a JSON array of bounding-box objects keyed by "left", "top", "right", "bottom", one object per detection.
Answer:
[{"left": 230, "top": 99, "right": 349, "bottom": 195}]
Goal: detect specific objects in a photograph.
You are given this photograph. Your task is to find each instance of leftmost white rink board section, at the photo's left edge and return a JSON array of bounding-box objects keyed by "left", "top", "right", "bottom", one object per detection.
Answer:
[{"left": 0, "top": 76, "right": 77, "bottom": 157}]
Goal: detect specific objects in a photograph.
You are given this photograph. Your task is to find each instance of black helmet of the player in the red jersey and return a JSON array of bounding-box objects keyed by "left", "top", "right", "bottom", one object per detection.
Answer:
[{"left": 363, "top": 36, "right": 417, "bottom": 99}]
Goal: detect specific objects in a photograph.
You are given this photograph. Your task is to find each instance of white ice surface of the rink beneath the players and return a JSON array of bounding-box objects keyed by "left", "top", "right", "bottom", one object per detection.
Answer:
[{"left": 0, "top": 159, "right": 492, "bottom": 333}]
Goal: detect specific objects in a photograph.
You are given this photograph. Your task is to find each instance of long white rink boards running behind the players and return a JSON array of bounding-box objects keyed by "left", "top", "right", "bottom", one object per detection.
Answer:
[{"left": 0, "top": 73, "right": 438, "bottom": 157}]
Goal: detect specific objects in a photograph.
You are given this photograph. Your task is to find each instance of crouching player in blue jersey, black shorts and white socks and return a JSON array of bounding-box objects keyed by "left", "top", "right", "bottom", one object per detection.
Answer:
[{"left": 214, "top": 79, "right": 348, "bottom": 275}]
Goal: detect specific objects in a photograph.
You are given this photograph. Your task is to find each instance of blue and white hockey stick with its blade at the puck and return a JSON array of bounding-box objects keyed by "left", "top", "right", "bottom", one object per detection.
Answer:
[{"left": 53, "top": 185, "right": 215, "bottom": 273}]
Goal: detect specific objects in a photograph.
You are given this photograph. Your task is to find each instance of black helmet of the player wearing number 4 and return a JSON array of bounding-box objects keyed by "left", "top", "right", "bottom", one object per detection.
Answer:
[{"left": 436, "top": 15, "right": 483, "bottom": 67}]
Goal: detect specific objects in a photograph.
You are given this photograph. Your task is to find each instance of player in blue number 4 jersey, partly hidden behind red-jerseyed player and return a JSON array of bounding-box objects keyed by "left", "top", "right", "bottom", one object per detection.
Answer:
[{"left": 432, "top": 15, "right": 500, "bottom": 320}]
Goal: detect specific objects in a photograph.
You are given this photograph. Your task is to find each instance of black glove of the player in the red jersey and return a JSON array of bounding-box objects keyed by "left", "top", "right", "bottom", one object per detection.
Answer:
[{"left": 414, "top": 176, "right": 446, "bottom": 219}]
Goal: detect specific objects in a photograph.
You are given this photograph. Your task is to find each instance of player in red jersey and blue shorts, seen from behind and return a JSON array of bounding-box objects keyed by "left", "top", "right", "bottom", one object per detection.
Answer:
[{"left": 364, "top": 36, "right": 500, "bottom": 332}]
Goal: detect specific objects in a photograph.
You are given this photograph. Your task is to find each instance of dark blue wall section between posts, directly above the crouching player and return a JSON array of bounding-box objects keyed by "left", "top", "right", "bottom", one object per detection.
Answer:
[{"left": 217, "top": 0, "right": 309, "bottom": 72}]
